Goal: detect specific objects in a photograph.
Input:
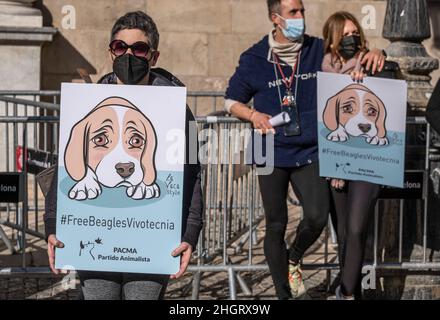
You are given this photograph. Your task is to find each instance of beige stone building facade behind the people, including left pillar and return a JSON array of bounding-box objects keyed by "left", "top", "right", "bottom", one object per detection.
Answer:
[{"left": 0, "top": 0, "right": 440, "bottom": 95}]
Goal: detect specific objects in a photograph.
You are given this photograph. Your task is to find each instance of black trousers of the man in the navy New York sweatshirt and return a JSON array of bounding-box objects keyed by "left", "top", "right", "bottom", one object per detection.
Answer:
[{"left": 259, "top": 163, "right": 330, "bottom": 299}]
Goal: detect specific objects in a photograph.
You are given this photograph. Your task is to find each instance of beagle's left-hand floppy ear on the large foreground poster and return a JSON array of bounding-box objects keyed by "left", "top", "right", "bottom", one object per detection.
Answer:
[{"left": 64, "top": 117, "right": 90, "bottom": 181}]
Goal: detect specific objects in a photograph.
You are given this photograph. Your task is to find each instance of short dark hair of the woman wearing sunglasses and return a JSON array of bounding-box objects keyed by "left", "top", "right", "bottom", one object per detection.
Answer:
[{"left": 111, "top": 11, "right": 159, "bottom": 50}]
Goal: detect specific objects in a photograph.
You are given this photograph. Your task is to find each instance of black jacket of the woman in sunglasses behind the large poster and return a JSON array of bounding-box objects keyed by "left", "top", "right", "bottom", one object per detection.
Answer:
[{"left": 44, "top": 68, "right": 203, "bottom": 249}]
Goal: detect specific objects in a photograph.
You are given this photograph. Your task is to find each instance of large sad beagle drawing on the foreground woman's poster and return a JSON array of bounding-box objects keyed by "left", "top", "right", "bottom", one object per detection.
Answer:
[{"left": 64, "top": 97, "right": 160, "bottom": 200}]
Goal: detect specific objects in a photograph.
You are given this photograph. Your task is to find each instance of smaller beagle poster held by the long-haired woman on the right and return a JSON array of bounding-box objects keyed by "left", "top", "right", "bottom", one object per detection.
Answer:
[{"left": 318, "top": 72, "right": 407, "bottom": 188}]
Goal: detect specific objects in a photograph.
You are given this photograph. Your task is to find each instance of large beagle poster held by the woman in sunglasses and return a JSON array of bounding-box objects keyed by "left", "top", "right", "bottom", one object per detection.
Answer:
[{"left": 55, "top": 83, "right": 186, "bottom": 274}]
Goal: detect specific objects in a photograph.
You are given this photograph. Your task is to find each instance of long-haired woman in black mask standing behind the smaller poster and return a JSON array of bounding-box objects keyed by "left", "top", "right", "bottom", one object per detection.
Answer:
[{"left": 322, "top": 12, "right": 381, "bottom": 300}]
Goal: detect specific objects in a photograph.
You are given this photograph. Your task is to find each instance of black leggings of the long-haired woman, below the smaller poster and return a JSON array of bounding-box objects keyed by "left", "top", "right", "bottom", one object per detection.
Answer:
[{"left": 332, "top": 181, "right": 380, "bottom": 295}]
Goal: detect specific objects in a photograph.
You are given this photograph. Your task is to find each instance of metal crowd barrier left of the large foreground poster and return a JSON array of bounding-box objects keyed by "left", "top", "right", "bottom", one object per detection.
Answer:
[{"left": 0, "top": 91, "right": 59, "bottom": 268}]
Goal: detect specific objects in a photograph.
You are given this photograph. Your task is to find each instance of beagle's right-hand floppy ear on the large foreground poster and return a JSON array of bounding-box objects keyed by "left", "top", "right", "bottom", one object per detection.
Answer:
[{"left": 140, "top": 116, "right": 157, "bottom": 186}]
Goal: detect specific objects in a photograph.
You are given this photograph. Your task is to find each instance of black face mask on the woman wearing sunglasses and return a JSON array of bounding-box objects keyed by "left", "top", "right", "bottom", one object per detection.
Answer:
[{"left": 113, "top": 54, "right": 150, "bottom": 84}]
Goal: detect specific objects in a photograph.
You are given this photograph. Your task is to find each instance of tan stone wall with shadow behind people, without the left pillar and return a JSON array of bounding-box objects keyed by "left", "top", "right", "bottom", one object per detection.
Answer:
[{"left": 37, "top": 0, "right": 440, "bottom": 91}]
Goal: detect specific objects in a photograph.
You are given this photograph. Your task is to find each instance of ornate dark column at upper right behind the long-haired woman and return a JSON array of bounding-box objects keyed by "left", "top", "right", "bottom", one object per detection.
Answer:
[{"left": 383, "top": 0, "right": 439, "bottom": 111}]
